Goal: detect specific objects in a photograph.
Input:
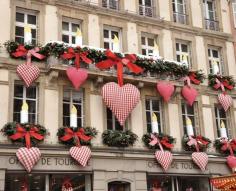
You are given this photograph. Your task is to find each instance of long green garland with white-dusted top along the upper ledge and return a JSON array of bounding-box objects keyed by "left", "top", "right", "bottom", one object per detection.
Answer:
[{"left": 4, "top": 41, "right": 204, "bottom": 81}]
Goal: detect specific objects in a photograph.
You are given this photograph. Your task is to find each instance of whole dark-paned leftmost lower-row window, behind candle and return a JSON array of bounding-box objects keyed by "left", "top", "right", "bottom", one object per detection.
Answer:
[{"left": 13, "top": 84, "right": 38, "bottom": 124}]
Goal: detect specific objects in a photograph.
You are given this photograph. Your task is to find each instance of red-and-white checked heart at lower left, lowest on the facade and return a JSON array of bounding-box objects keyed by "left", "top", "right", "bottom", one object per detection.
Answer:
[{"left": 16, "top": 147, "right": 41, "bottom": 172}]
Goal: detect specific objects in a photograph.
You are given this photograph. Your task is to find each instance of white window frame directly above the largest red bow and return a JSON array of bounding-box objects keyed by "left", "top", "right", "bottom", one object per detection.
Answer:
[{"left": 103, "top": 25, "right": 122, "bottom": 52}]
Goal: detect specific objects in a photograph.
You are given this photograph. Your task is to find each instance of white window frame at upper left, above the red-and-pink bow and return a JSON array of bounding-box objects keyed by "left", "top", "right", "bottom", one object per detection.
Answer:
[{"left": 14, "top": 8, "right": 38, "bottom": 44}]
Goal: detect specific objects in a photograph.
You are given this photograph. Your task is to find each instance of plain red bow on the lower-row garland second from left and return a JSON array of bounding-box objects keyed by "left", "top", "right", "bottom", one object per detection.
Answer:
[{"left": 60, "top": 127, "right": 91, "bottom": 145}]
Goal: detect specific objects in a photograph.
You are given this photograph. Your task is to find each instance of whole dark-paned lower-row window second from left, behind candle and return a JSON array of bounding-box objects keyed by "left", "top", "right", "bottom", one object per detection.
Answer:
[{"left": 63, "top": 89, "right": 84, "bottom": 127}]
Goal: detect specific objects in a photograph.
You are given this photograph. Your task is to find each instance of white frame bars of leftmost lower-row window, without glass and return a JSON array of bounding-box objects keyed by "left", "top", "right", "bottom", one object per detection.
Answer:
[{"left": 12, "top": 82, "right": 39, "bottom": 124}]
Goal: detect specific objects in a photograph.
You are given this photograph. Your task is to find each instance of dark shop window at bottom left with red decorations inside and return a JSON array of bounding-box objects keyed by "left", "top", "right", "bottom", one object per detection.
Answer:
[{"left": 5, "top": 173, "right": 92, "bottom": 191}]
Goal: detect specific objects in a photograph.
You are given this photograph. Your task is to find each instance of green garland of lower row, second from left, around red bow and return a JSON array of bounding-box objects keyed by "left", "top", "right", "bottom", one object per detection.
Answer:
[{"left": 57, "top": 127, "right": 98, "bottom": 146}]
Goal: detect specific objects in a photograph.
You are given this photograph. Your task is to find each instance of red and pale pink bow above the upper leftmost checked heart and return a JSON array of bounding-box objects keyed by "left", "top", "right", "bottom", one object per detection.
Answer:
[{"left": 12, "top": 45, "right": 45, "bottom": 64}]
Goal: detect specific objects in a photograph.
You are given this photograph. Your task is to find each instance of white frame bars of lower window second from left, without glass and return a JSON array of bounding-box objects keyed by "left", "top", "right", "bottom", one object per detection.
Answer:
[{"left": 62, "top": 86, "right": 85, "bottom": 127}]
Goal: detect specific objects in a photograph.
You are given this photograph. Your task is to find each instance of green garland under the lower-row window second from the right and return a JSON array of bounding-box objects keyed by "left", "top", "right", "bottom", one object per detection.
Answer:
[{"left": 182, "top": 135, "right": 211, "bottom": 152}]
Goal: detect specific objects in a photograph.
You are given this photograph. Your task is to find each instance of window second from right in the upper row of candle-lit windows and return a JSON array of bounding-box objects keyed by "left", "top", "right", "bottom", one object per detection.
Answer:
[{"left": 176, "top": 42, "right": 191, "bottom": 68}]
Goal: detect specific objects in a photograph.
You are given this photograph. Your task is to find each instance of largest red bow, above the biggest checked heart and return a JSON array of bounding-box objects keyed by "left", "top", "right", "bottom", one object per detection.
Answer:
[{"left": 96, "top": 50, "right": 143, "bottom": 86}]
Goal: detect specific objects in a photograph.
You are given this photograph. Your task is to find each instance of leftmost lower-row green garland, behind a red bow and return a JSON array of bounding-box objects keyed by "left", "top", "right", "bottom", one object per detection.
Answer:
[{"left": 1, "top": 122, "right": 47, "bottom": 146}]
